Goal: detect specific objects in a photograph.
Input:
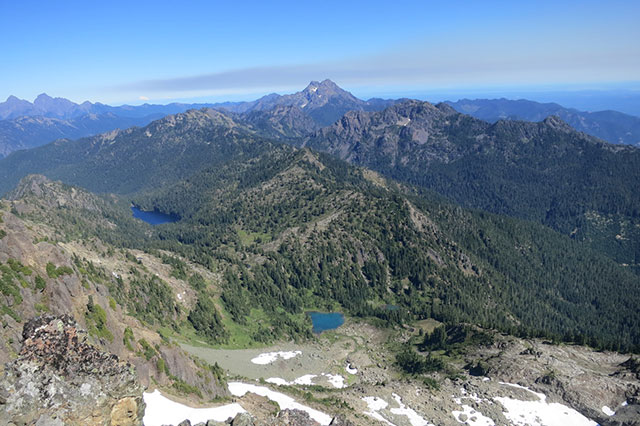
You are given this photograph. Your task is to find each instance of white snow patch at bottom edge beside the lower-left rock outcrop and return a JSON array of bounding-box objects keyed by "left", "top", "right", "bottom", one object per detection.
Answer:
[{"left": 142, "top": 389, "right": 245, "bottom": 426}]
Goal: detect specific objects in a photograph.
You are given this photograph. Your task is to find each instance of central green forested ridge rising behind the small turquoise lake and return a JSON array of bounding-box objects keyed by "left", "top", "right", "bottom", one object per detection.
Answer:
[{"left": 11, "top": 147, "right": 639, "bottom": 350}]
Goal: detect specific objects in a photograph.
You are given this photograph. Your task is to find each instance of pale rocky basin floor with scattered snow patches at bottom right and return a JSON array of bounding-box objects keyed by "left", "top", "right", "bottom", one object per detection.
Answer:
[{"left": 148, "top": 319, "right": 640, "bottom": 426}]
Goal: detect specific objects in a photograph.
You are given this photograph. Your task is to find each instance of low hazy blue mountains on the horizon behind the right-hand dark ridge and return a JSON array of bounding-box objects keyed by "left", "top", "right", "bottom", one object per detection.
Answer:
[{"left": 447, "top": 98, "right": 640, "bottom": 146}]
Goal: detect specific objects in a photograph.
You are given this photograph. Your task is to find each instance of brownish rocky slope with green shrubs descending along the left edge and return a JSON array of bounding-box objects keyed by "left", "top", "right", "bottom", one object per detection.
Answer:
[{"left": 0, "top": 176, "right": 228, "bottom": 400}]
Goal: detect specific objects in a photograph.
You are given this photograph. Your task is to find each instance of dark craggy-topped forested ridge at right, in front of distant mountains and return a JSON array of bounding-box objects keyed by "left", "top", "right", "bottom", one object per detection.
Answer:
[{"left": 302, "top": 101, "right": 640, "bottom": 267}]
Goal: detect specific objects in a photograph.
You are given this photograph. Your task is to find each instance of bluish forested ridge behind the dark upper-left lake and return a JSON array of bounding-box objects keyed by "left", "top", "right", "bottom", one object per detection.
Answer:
[{"left": 0, "top": 109, "right": 278, "bottom": 193}]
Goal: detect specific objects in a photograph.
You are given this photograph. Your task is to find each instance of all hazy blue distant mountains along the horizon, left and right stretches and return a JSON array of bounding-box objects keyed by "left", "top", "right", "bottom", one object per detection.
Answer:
[{"left": 0, "top": 80, "right": 640, "bottom": 158}]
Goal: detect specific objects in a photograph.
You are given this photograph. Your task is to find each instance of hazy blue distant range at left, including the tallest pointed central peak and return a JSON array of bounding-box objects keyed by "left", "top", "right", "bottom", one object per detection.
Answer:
[{"left": 0, "top": 80, "right": 397, "bottom": 158}]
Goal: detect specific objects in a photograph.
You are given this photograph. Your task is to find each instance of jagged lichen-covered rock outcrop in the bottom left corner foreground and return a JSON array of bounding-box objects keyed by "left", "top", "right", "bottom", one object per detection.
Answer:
[{"left": 0, "top": 315, "right": 144, "bottom": 426}]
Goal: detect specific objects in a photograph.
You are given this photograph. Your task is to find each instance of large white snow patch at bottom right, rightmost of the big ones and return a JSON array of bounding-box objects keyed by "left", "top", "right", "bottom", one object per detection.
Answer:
[{"left": 493, "top": 382, "right": 597, "bottom": 426}]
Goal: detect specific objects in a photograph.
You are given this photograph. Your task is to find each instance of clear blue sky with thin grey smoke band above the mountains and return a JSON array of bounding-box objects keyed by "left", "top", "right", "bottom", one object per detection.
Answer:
[{"left": 0, "top": 0, "right": 640, "bottom": 104}]
